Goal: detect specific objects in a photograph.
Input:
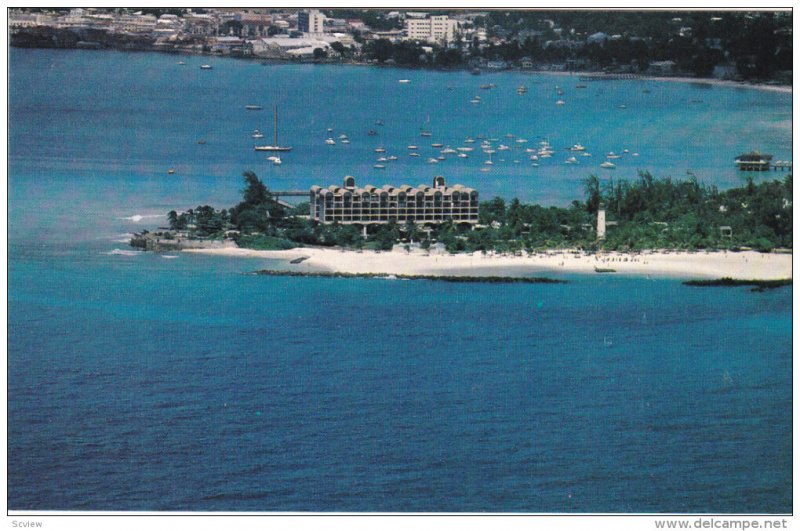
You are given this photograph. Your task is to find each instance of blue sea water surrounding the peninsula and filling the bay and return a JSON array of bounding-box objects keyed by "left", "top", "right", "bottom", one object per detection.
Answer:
[{"left": 8, "top": 49, "right": 792, "bottom": 512}]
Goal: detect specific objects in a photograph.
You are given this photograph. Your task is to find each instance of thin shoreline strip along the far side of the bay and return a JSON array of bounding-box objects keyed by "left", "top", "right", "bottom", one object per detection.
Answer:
[{"left": 11, "top": 46, "right": 792, "bottom": 94}]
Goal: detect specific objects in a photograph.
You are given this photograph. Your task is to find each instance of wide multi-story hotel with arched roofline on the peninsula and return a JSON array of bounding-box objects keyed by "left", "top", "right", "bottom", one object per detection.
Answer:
[{"left": 310, "top": 176, "right": 478, "bottom": 225}]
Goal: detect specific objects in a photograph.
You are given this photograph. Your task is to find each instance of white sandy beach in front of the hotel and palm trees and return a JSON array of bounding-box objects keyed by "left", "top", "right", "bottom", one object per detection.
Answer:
[{"left": 184, "top": 247, "right": 792, "bottom": 280}]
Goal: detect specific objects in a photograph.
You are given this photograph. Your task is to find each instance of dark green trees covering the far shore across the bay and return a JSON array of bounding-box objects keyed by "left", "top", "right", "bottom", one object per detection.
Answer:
[{"left": 354, "top": 10, "right": 792, "bottom": 79}]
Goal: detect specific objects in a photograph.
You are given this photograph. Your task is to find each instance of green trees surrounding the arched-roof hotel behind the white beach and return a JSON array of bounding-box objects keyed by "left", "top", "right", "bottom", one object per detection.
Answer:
[{"left": 168, "top": 171, "right": 792, "bottom": 252}]
